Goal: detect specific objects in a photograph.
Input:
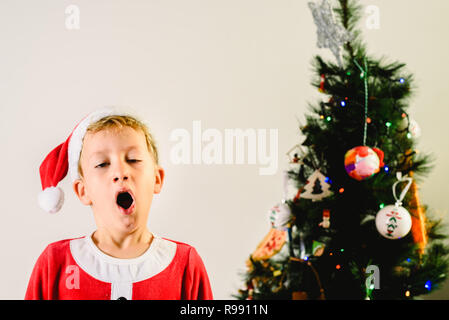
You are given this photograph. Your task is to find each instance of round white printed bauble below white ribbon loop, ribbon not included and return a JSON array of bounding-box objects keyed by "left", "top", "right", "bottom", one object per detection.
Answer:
[{"left": 376, "top": 205, "right": 412, "bottom": 240}]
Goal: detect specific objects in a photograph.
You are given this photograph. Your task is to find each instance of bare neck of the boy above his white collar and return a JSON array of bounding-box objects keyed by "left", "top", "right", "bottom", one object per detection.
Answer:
[{"left": 92, "top": 227, "right": 153, "bottom": 259}]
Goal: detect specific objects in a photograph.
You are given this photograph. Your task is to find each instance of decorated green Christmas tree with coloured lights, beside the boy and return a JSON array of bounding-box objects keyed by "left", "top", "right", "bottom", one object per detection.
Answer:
[{"left": 234, "top": 0, "right": 449, "bottom": 299}]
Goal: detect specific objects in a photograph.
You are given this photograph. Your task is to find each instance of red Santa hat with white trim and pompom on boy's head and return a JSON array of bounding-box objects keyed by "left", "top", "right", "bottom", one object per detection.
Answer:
[{"left": 38, "top": 107, "right": 139, "bottom": 213}]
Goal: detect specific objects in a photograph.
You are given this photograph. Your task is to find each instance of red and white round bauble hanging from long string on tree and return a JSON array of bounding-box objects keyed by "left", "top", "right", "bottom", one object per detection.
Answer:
[{"left": 345, "top": 146, "right": 385, "bottom": 181}]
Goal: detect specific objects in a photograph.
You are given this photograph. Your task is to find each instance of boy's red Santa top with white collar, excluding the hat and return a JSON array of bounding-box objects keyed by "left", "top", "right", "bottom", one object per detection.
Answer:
[{"left": 25, "top": 231, "right": 213, "bottom": 300}]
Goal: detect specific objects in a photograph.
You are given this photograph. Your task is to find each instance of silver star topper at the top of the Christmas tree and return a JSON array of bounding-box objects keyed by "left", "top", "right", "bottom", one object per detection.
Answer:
[{"left": 308, "top": 0, "right": 352, "bottom": 67}]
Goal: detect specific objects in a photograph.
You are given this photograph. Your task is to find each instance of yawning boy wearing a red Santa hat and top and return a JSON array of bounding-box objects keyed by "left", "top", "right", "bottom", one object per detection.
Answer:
[{"left": 25, "top": 108, "right": 213, "bottom": 300}]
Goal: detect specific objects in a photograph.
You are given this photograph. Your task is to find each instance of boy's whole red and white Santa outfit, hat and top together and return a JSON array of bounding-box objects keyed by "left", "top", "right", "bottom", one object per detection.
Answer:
[{"left": 25, "top": 108, "right": 213, "bottom": 300}]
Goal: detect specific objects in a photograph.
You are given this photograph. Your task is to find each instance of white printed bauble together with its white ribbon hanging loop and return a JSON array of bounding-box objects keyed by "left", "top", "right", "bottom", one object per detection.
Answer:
[{"left": 376, "top": 172, "right": 412, "bottom": 239}]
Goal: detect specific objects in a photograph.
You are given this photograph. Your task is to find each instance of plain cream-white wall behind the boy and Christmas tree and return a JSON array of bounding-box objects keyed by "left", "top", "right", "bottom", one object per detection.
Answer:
[{"left": 0, "top": 0, "right": 449, "bottom": 299}]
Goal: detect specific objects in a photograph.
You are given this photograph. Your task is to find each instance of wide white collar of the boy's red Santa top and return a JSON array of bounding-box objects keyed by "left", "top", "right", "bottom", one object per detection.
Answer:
[{"left": 70, "top": 234, "right": 177, "bottom": 283}]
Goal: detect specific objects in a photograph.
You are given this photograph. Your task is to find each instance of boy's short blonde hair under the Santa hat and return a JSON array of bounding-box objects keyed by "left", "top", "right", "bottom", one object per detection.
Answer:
[{"left": 78, "top": 115, "right": 159, "bottom": 177}]
